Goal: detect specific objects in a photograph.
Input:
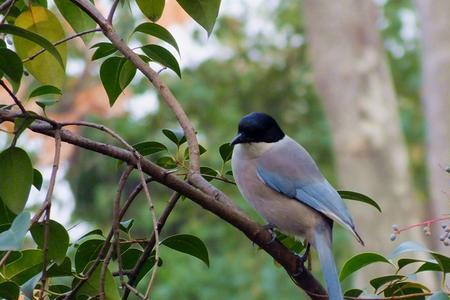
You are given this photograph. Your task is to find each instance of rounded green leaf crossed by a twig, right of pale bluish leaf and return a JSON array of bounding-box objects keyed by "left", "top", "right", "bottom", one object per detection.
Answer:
[{"left": 30, "top": 220, "right": 69, "bottom": 264}]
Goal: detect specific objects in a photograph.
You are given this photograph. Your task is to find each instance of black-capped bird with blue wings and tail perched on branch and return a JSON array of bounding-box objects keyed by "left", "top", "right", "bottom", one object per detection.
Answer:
[{"left": 230, "top": 112, "right": 364, "bottom": 300}]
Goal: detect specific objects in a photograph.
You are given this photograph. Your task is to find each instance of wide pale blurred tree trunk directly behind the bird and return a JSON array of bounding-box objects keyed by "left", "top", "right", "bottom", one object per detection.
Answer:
[{"left": 304, "top": 0, "right": 422, "bottom": 288}]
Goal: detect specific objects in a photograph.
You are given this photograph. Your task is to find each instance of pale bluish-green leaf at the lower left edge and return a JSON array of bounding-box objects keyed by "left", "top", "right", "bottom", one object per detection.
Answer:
[{"left": 0, "top": 211, "right": 30, "bottom": 251}]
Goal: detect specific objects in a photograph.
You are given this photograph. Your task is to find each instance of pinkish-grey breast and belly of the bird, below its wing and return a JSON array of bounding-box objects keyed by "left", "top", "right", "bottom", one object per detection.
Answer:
[{"left": 232, "top": 151, "right": 322, "bottom": 240}]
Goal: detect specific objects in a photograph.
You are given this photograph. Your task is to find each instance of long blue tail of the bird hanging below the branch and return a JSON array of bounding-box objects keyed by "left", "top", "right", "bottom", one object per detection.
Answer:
[{"left": 314, "top": 228, "right": 344, "bottom": 300}]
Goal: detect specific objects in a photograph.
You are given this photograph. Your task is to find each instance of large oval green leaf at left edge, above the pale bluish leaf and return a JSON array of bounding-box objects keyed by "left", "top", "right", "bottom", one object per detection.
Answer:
[{"left": 0, "top": 147, "right": 33, "bottom": 213}]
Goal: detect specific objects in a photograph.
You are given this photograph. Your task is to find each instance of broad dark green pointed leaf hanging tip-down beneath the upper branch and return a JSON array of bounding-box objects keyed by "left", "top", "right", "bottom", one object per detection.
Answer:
[{"left": 100, "top": 56, "right": 136, "bottom": 106}]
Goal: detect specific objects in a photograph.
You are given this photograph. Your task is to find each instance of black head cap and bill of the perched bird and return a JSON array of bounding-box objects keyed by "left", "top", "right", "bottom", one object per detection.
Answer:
[{"left": 231, "top": 112, "right": 284, "bottom": 145}]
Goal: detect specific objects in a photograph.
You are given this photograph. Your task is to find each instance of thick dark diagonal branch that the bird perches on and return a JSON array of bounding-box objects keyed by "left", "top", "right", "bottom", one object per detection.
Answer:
[{"left": 0, "top": 110, "right": 325, "bottom": 299}]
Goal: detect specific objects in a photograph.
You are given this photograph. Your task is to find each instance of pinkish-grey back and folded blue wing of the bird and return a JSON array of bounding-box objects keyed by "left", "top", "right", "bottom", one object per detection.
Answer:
[{"left": 256, "top": 138, "right": 360, "bottom": 240}]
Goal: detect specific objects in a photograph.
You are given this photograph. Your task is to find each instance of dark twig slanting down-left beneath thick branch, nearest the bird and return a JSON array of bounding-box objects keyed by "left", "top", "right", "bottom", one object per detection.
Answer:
[{"left": 122, "top": 192, "right": 181, "bottom": 300}]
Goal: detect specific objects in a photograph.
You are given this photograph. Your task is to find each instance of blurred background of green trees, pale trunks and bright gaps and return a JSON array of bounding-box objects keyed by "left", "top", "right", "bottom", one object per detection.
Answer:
[{"left": 0, "top": 0, "right": 450, "bottom": 299}]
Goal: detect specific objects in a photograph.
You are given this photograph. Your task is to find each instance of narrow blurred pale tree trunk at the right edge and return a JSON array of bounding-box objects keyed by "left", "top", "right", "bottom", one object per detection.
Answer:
[{"left": 416, "top": 0, "right": 450, "bottom": 251}]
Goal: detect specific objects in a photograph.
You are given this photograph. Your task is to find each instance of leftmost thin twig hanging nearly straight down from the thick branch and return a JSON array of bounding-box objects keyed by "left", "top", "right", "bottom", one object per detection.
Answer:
[{"left": 39, "top": 128, "right": 61, "bottom": 300}]
